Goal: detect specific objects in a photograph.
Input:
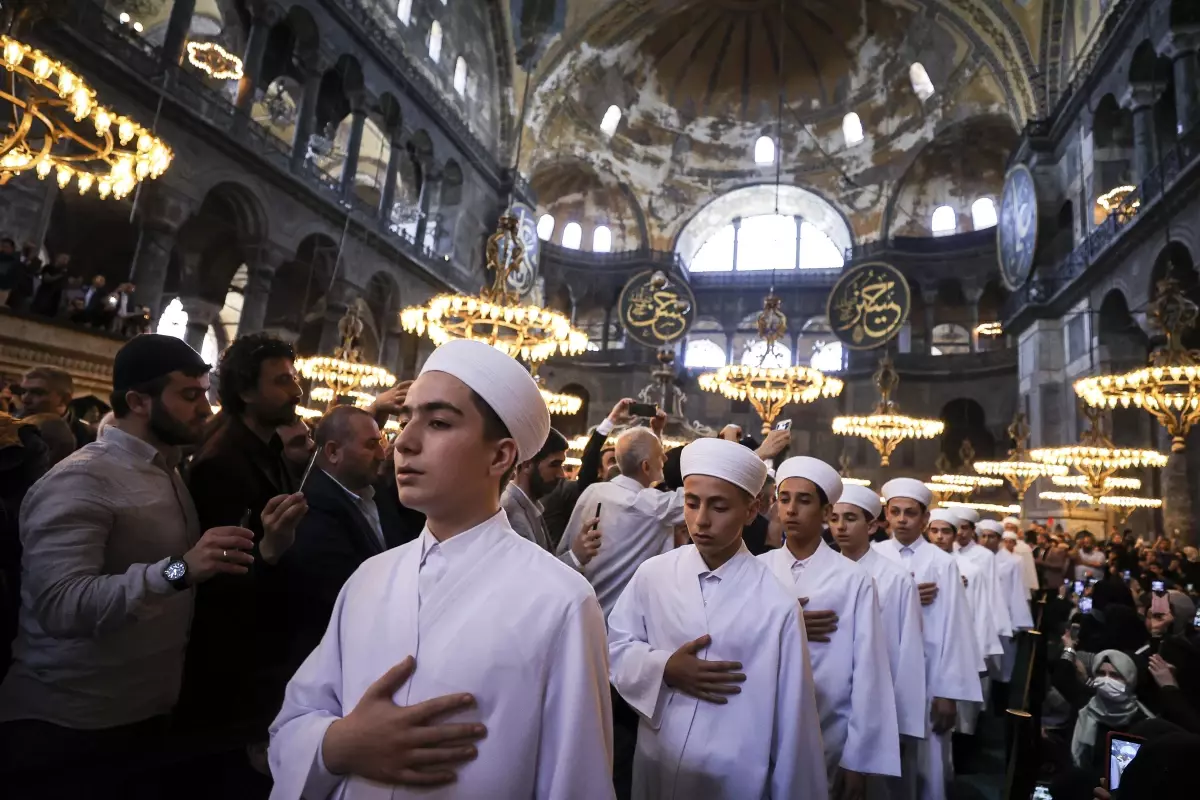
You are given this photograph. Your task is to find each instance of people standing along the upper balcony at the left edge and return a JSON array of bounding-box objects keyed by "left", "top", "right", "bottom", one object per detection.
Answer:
[{"left": 0, "top": 237, "right": 150, "bottom": 338}]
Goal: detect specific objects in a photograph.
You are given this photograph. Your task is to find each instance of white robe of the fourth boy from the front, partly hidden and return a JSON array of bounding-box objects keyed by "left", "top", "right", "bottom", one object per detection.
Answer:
[{"left": 858, "top": 549, "right": 929, "bottom": 739}]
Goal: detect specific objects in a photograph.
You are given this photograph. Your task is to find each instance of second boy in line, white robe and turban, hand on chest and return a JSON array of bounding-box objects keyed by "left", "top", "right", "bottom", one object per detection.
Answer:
[{"left": 609, "top": 439, "right": 828, "bottom": 800}]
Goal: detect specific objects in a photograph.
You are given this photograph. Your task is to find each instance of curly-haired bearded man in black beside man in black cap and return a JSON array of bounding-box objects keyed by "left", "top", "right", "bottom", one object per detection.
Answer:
[{"left": 179, "top": 333, "right": 307, "bottom": 796}]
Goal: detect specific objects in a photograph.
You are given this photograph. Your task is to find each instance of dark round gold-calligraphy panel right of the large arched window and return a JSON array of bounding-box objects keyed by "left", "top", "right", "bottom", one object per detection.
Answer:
[{"left": 826, "top": 261, "right": 912, "bottom": 350}]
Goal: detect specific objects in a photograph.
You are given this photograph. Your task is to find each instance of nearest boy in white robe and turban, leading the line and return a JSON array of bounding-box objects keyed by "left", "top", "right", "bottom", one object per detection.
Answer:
[{"left": 270, "top": 341, "right": 613, "bottom": 800}]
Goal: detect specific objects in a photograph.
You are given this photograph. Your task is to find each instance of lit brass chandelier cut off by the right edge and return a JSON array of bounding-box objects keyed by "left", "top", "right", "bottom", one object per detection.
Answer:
[{"left": 1075, "top": 275, "right": 1200, "bottom": 453}]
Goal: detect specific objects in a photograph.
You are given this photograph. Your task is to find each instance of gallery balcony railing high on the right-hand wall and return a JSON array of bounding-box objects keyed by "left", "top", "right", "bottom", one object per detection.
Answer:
[{"left": 1003, "top": 109, "right": 1200, "bottom": 327}]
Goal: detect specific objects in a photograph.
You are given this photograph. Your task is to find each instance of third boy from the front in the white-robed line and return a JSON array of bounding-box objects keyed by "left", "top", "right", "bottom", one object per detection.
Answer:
[{"left": 758, "top": 456, "right": 900, "bottom": 800}]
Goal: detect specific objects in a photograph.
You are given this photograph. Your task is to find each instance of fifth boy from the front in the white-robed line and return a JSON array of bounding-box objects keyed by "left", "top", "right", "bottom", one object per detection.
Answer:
[{"left": 872, "top": 477, "right": 983, "bottom": 800}]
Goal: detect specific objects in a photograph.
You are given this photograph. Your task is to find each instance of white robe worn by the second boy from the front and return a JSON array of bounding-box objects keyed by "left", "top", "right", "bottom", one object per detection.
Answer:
[{"left": 609, "top": 545, "right": 828, "bottom": 800}]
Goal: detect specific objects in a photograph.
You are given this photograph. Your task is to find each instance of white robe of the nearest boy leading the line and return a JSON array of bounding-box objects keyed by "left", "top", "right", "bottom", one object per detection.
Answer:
[{"left": 270, "top": 511, "right": 613, "bottom": 800}]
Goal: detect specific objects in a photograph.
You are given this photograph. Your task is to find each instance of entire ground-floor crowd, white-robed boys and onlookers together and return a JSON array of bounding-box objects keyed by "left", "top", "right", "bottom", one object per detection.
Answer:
[{"left": 0, "top": 333, "right": 1200, "bottom": 800}]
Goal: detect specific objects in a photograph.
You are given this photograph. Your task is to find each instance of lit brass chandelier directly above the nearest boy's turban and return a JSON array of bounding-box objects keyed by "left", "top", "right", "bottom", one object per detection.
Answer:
[{"left": 400, "top": 211, "right": 588, "bottom": 363}]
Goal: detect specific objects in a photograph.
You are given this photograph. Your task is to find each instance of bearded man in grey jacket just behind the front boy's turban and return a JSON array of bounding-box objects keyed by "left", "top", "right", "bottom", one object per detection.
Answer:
[{"left": 500, "top": 428, "right": 600, "bottom": 570}]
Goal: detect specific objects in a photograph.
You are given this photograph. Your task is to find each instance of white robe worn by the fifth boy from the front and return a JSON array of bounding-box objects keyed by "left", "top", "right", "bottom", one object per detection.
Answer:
[{"left": 871, "top": 536, "right": 983, "bottom": 800}]
